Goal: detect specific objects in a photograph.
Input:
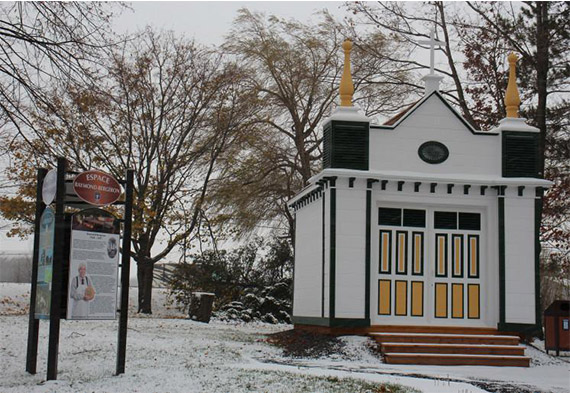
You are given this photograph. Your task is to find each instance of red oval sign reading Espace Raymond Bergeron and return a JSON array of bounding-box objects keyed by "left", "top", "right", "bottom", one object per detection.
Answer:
[{"left": 73, "top": 171, "right": 121, "bottom": 206}]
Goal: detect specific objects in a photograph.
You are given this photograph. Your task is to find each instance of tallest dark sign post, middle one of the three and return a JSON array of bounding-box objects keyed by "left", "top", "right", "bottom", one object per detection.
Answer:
[{"left": 47, "top": 157, "right": 65, "bottom": 381}]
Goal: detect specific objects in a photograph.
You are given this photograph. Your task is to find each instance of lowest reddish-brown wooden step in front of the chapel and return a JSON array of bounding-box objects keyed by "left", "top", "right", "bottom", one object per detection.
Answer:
[{"left": 384, "top": 353, "right": 530, "bottom": 367}]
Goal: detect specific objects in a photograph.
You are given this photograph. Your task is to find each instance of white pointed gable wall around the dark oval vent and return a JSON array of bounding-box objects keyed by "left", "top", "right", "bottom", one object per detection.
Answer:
[{"left": 370, "top": 96, "right": 501, "bottom": 176}]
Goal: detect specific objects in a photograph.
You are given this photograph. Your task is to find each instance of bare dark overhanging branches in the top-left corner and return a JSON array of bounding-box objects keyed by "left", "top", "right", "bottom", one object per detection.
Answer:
[{"left": 0, "top": 1, "right": 123, "bottom": 137}]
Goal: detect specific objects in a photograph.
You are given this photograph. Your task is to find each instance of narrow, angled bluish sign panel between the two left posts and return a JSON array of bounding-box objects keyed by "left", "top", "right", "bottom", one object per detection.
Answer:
[{"left": 34, "top": 207, "right": 55, "bottom": 319}]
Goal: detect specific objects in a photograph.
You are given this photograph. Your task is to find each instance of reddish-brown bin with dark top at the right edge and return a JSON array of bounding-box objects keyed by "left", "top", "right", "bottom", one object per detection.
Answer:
[{"left": 544, "top": 300, "right": 570, "bottom": 356}]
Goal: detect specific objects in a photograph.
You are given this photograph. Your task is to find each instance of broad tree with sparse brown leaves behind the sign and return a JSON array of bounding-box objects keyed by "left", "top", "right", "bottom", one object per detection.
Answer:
[{"left": 2, "top": 30, "right": 255, "bottom": 313}]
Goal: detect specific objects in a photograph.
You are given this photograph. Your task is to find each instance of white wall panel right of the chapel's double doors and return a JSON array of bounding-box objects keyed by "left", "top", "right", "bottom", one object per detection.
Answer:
[{"left": 505, "top": 197, "right": 536, "bottom": 323}]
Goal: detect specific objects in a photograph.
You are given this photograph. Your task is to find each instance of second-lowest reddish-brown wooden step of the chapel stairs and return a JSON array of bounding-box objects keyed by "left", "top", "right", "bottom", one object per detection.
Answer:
[{"left": 381, "top": 342, "right": 525, "bottom": 356}]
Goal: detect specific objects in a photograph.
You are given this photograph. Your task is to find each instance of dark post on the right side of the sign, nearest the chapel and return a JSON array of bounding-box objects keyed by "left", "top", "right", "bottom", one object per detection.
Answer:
[{"left": 117, "top": 169, "right": 134, "bottom": 375}]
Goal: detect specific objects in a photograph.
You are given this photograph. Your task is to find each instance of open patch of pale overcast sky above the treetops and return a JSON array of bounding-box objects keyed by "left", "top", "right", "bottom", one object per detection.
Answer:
[{"left": 115, "top": 1, "right": 348, "bottom": 45}]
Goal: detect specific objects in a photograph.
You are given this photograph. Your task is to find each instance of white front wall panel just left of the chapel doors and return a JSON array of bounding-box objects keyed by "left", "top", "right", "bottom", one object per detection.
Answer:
[{"left": 335, "top": 178, "right": 366, "bottom": 318}]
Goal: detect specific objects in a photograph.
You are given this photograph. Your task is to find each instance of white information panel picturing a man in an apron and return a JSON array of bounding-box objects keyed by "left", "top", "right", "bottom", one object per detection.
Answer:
[{"left": 67, "top": 209, "right": 119, "bottom": 319}]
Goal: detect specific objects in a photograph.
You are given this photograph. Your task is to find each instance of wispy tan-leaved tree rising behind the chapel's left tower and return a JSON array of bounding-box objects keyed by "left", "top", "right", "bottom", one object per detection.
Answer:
[{"left": 211, "top": 9, "right": 407, "bottom": 235}]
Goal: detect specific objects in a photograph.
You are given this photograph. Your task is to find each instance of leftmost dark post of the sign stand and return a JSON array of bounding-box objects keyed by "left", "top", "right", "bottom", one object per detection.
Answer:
[{"left": 26, "top": 168, "right": 47, "bottom": 374}]
